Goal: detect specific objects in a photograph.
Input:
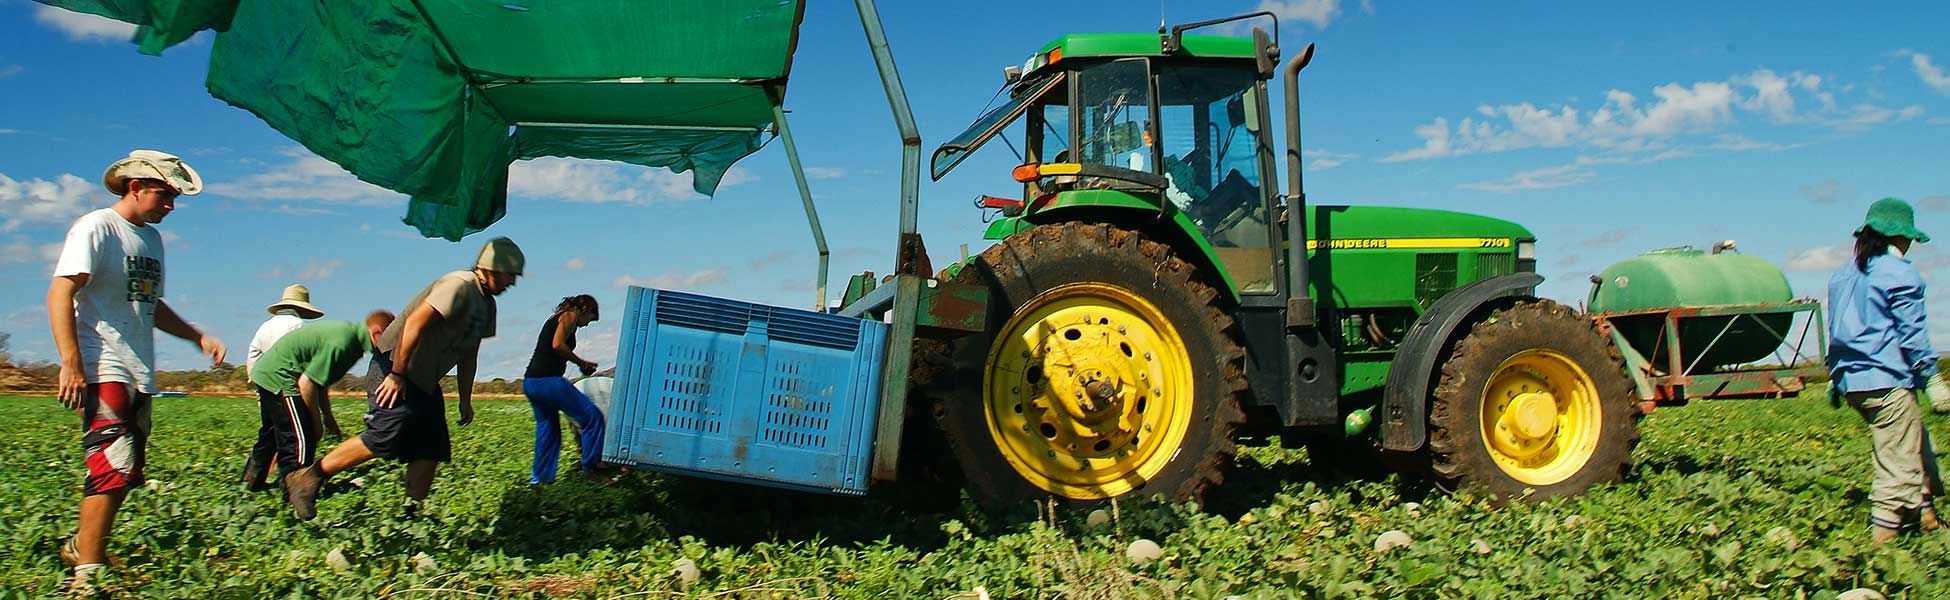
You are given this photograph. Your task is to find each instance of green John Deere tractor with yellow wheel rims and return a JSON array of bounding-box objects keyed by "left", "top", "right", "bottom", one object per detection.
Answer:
[{"left": 911, "top": 14, "right": 1642, "bottom": 505}]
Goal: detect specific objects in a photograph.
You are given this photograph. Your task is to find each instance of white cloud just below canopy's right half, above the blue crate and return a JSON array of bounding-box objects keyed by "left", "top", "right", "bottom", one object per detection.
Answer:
[{"left": 507, "top": 158, "right": 757, "bottom": 205}]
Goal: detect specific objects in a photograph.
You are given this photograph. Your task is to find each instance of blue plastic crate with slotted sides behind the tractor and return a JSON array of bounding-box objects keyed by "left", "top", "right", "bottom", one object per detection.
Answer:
[{"left": 603, "top": 286, "right": 887, "bottom": 495}]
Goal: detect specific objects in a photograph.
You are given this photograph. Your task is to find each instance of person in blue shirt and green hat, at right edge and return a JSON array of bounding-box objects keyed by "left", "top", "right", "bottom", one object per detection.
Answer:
[{"left": 1827, "top": 199, "right": 1950, "bottom": 544}]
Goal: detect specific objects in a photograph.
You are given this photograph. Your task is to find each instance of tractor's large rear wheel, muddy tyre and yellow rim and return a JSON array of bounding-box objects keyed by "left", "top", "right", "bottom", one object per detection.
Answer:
[{"left": 932, "top": 222, "right": 1246, "bottom": 508}]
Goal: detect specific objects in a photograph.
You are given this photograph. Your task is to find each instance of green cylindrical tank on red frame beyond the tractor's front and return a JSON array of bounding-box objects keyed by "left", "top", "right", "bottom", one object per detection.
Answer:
[{"left": 1585, "top": 247, "right": 1794, "bottom": 368}]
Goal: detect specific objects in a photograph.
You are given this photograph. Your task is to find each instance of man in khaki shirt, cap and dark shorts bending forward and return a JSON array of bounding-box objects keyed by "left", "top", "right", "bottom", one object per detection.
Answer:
[{"left": 285, "top": 238, "right": 525, "bottom": 520}]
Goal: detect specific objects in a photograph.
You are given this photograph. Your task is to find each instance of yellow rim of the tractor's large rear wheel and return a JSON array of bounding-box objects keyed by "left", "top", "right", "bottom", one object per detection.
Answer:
[{"left": 983, "top": 282, "right": 1193, "bottom": 499}]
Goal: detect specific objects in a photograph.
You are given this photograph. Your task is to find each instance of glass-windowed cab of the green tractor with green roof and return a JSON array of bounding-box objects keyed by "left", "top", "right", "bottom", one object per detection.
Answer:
[{"left": 930, "top": 33, "right": 1275, "bottom": 292}]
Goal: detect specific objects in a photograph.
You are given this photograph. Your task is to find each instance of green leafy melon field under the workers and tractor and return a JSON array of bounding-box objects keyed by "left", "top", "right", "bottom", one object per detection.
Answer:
[{"left": 0, "top": 395, "right": 1950, "bottom": 598}]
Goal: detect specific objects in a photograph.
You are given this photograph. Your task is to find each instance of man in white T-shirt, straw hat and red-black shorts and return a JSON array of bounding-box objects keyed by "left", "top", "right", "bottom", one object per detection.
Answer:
[{"left": 47, "top": 150, "right": 224, "bottom": 594}]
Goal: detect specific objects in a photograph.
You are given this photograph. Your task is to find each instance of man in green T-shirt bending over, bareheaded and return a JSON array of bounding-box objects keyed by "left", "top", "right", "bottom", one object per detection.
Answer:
[{"left": 250, "top": 310, "right": 394, "bottom": 477}]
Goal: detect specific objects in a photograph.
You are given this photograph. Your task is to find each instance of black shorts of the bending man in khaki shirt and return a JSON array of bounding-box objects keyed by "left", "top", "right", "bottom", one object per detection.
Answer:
[{"left": 359, "top": 353, "right": 454, "bottom": 462}]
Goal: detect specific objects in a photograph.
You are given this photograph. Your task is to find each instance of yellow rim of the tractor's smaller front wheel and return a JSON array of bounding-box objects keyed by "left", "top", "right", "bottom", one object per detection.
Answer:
[{"left": 1480, "top": 351, "right": 1603, "bottom": 485}]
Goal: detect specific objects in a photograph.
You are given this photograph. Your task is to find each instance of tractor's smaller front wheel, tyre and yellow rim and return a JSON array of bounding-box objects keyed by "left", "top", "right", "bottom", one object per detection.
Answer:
[{"left": 1429, "top": 300, "right": 1640, "bottom": 499}]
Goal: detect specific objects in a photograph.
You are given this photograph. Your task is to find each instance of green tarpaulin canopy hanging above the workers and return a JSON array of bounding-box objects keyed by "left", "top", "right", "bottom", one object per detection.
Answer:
[{"left": 39, "top": 0, "right": 803, "bottom": 240}]
